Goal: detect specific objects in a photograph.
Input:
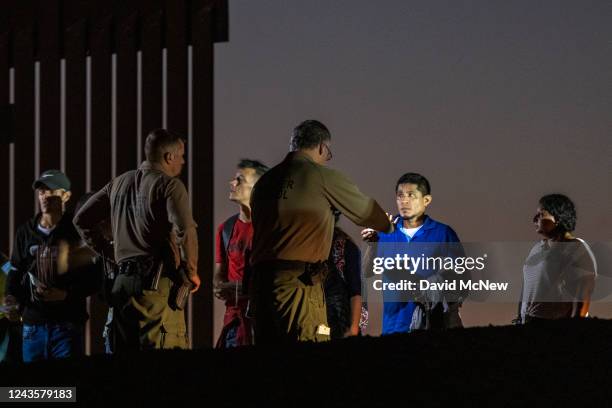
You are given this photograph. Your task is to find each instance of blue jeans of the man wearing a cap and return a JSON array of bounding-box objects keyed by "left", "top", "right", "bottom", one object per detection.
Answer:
[{"left": 23, "top": 322, "right": 83, "bottom": 363}]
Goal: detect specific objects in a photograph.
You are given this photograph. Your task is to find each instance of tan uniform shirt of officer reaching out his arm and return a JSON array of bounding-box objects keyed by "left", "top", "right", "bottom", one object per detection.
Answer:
[{"left": 251, "top": 152, "right": 392, "bottom": 265}]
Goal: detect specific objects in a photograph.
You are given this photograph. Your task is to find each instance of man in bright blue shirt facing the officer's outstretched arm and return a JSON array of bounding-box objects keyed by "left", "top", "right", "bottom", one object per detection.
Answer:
[{"left": 361, "top": 173, "right": 467, "bottom": 334}]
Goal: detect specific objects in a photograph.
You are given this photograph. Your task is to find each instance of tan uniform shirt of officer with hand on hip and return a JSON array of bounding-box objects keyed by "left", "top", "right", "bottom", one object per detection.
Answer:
[{"left": 74, "top": 161, "right": 198, "bottom": 275}]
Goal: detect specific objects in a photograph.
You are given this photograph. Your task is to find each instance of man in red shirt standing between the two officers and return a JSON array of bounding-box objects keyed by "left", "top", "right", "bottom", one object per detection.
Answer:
[{"left": 214, "top": 159, "right": 268, "bottom": 348}]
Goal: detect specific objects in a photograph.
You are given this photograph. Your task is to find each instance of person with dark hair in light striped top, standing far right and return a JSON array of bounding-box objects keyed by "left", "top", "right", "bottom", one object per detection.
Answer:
[{"left": 518, "top": 194, "right": 597, "bottom": 323}]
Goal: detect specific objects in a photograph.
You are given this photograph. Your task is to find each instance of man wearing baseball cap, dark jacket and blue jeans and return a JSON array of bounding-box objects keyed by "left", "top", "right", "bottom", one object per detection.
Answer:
[{"left": 4, "top": 170, "right": 98, "bottom": 362}]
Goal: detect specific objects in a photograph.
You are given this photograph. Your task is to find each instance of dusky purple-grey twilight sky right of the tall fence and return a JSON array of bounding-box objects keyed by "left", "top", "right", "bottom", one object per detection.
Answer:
[{"left": 212, "top": 0, "right": 612, "bottom": 332}]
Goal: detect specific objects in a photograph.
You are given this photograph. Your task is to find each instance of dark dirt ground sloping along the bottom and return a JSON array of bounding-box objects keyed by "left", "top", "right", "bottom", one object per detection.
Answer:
[{"left": 0, "top": 319, "right": 612, "bottom": 407}]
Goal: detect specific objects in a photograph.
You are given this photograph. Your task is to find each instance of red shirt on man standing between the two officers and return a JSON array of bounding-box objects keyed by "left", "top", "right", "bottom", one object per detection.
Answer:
[{"left": 215, "top": 219, "right": 253, "bottom": 282}]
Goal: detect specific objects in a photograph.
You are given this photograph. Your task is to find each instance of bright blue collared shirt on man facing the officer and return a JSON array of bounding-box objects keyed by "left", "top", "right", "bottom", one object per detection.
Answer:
[{"left": 378, "top": 215, "right": 460, "bottom": 335}]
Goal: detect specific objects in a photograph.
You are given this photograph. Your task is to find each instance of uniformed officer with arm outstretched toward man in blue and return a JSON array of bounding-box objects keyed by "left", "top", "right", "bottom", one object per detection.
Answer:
[{"left": 251, "top": 120, "right": 393, "bottom": 344}]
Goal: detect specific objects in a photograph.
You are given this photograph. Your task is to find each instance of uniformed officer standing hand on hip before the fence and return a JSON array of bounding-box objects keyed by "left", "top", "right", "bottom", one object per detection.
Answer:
[{"left": 74, "top": 129, "right": 200, "bottom": 352}]
